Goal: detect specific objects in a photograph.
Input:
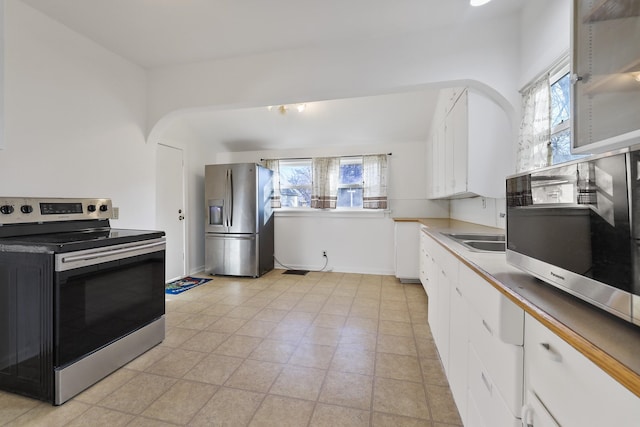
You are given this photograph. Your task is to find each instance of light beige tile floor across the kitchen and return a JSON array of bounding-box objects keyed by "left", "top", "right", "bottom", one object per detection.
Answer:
[{"left": 0, "top": 270, "right": 461, "bottom": 427}]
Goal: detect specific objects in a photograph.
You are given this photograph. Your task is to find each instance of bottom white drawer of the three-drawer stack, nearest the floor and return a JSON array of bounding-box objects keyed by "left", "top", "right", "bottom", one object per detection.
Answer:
[{"left": 467, "top": 345, "right": 520, "bottom": 427}]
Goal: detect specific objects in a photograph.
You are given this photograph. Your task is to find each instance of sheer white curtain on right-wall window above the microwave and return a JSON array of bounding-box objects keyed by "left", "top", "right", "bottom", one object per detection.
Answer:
[{"left": 516, "top": 75, "right": 552, "bottom": 172}]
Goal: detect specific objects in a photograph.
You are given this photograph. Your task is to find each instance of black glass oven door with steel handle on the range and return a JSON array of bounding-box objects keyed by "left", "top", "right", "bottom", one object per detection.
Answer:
[{"left": 54, "top": 239, "right": 165, "bottom": 368}]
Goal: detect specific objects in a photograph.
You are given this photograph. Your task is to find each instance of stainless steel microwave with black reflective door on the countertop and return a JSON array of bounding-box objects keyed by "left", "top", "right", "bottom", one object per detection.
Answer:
[{"left": 506, "top": 146, "right": 640, "bottom": 325}]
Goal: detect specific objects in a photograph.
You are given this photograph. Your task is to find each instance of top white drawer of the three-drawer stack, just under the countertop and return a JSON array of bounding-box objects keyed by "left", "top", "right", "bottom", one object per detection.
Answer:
[{"left": 459, "top": 265, "right": 524, "bottom": 345}]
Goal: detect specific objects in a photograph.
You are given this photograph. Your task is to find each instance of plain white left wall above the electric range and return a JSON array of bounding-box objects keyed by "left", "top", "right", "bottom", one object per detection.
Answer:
[{"left": 0, "top": 0, "right": 155, "bottom": 228}]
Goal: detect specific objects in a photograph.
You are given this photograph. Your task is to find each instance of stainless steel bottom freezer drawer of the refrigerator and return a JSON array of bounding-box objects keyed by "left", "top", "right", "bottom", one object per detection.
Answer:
[{"left": 209, "top": 234, "right": 260, "bottom": 277}]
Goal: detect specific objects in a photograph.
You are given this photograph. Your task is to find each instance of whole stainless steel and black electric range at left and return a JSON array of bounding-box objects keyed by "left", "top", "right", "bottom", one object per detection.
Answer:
[{"left": 0, "top": 197, "right": 165, "bottom": 405}]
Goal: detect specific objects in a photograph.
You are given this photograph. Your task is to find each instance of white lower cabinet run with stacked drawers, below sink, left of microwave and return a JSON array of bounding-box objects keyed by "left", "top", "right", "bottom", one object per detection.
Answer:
[{"left": 420, "top": 232, "right": 524, "bottom": 427}]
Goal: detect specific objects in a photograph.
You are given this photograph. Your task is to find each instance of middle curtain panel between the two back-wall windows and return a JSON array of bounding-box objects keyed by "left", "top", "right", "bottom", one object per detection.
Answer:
[{"left": 311, "top": 157, "right": 340, "bottom": 209}]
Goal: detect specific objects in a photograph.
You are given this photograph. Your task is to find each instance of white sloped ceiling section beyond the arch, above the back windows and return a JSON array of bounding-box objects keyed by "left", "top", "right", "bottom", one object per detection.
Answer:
[{"left": 183, "top": 89, "right": 437, "bottom": 151}]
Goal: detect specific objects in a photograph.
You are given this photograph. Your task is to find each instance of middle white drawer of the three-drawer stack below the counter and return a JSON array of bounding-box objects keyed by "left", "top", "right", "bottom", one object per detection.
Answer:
[{"left": 468, "top": 311, "right": 524, "bottom": 416}]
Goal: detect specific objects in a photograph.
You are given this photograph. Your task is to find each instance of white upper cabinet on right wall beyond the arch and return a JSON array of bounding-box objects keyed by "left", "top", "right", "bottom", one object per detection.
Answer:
[{"left": 427, "top": 88, "right": 514, "bottom": 199}]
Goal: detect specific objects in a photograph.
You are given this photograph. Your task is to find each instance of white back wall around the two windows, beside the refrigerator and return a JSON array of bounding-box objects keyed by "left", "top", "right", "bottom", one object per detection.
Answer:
[{"left": 203, "top": 141, "right": 449, "bottom": 274}]
